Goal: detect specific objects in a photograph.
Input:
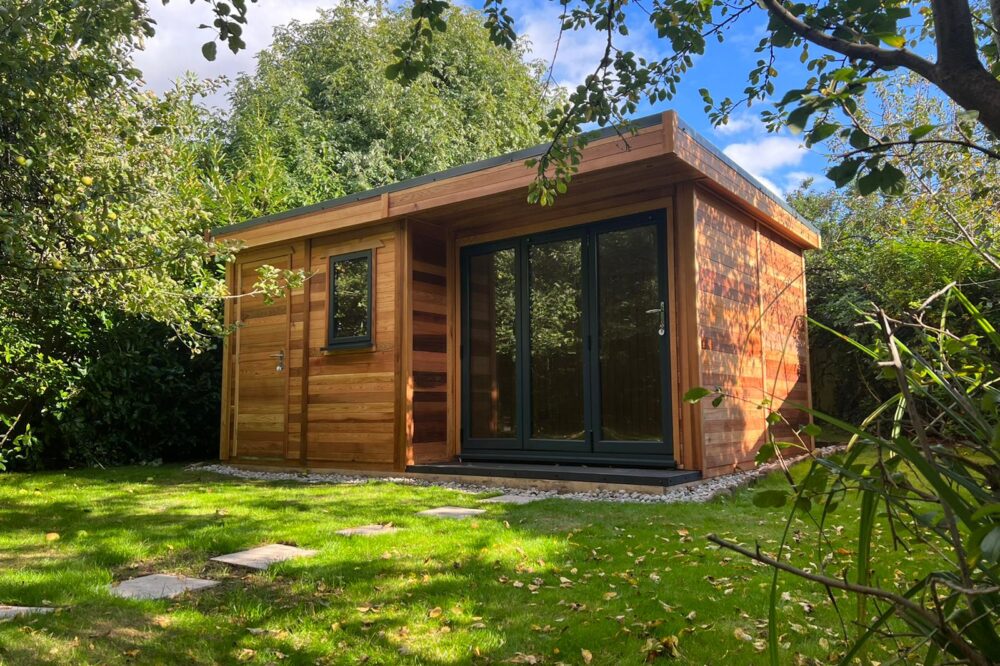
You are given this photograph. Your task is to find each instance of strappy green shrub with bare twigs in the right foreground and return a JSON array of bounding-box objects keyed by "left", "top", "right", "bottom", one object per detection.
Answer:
[{"left": 689, "top": 285, "right": 1000, "bottom": 664}]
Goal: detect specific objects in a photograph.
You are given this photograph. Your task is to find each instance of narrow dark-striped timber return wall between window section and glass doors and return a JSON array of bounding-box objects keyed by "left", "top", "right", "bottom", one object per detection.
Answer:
[{"left": 410, "top": 222, "right": 450, "bottom": 463}]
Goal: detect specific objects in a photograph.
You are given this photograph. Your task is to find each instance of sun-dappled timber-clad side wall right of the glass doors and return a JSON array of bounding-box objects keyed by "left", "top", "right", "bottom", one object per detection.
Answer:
[{"left": 695, "top": 189, "right": 809, "bottom": 476}]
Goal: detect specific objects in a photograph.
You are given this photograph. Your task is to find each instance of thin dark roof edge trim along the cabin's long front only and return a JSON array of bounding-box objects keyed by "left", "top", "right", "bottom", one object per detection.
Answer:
[{"left": 212, "top": 113, "right": 663, "bottom": 235}]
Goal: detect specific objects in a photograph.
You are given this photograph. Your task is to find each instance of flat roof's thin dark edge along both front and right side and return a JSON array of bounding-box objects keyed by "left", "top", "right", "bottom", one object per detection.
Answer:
[{"left": 211, "top": 113, "right": 819, "bottom": 235}]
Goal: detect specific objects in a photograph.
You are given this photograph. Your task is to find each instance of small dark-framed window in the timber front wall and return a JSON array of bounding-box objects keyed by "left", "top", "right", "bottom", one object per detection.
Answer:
[{"left": 326, "top": 250, "right": 372, "bottom": 349}]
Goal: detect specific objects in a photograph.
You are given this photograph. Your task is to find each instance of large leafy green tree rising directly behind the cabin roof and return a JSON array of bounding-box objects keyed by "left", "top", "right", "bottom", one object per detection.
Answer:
[{"left": 219, "top": 3, "right": 551, "bottom": 222}]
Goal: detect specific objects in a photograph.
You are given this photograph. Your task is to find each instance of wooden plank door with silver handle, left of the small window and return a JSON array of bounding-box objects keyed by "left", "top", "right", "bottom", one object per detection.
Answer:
[{"left": 231, "top": 254, "right": 291, "bottom": 459}]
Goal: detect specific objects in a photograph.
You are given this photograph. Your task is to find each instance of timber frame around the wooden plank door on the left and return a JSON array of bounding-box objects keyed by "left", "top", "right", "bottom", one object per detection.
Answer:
[{"left": 229, "top": 248, "right": 293, "bottom": 460}]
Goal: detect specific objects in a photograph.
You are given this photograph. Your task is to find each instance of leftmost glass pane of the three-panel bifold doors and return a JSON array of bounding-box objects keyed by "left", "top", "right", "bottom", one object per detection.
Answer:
[{"left": 466, "top": 247, "right": 518, "bottom": 444}]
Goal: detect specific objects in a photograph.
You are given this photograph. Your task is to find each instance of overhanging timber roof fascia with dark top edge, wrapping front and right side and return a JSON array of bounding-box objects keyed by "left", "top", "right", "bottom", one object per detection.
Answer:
[{"left": 212, "top": 111, "right": 820, "bottom": 248}]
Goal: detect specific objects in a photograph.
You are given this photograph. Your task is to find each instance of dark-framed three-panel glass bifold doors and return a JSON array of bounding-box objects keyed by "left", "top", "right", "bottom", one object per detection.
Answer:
[{"left": 462, "top": 211, "right": 674, "bottom": 467}]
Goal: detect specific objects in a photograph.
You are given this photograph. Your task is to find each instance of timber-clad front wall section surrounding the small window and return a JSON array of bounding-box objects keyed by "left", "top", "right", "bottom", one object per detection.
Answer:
[{"left": 304, "top": 225, "right": 398, "bottom": 468}]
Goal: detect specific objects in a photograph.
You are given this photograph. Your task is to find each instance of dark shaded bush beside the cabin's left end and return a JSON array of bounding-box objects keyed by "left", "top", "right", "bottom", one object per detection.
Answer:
[{"left": 29, "top": 315, "right": 222, "bottom": 468}]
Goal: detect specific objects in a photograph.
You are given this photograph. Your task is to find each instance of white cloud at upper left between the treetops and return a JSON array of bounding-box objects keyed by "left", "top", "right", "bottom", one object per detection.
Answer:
[{"left": 135, "top": 0, "right": 338, "bottom": 106}]
